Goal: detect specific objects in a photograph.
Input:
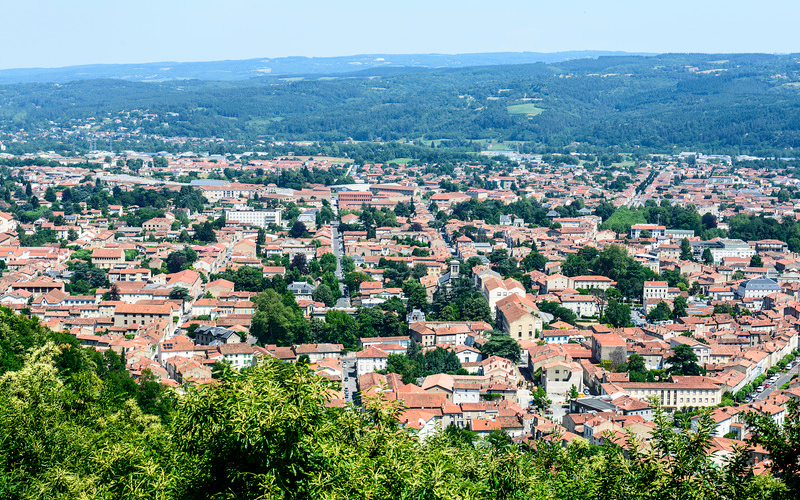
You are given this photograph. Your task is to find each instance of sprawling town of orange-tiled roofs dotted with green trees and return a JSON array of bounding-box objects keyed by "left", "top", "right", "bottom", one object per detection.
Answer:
[{"left": 0, "top": 147, "right": 800, "bottom": 474}]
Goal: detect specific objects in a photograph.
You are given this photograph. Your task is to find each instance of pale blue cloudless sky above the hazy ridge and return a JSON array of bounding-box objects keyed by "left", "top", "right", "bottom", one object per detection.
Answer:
[{"left": 0, "top": 0, "right": 800, "bottom": 69}]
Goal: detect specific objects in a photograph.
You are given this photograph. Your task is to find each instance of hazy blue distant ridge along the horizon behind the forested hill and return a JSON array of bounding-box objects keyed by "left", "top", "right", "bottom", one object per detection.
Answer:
[{"left": 0, "top": 50, "right": 655, "bottom": 84}]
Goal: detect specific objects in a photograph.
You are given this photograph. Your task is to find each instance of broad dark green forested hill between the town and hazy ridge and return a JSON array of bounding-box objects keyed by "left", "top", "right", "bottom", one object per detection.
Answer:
[{"left": 0, "top": 54, "right": 800, "bottom": 154}]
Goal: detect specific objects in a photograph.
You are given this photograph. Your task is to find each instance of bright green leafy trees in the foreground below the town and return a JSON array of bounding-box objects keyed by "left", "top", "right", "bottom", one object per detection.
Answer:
[{"left": 0, "top": 308, "right": 799, "bottom": 500}]
